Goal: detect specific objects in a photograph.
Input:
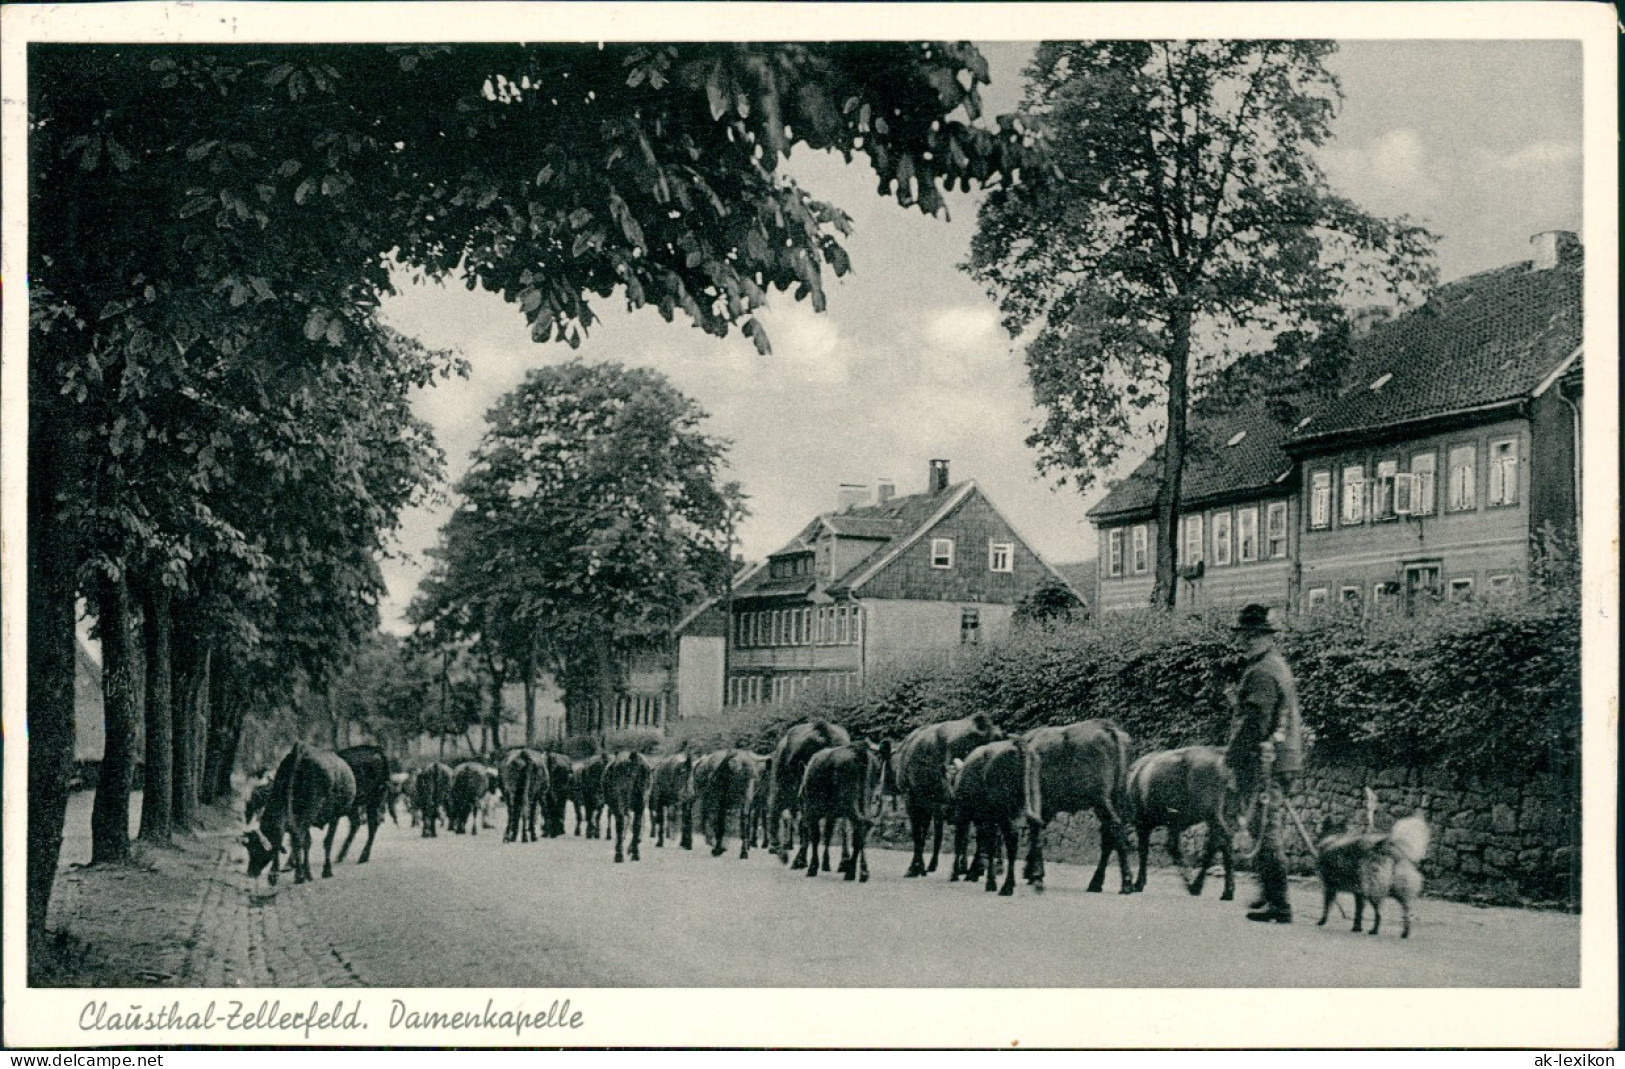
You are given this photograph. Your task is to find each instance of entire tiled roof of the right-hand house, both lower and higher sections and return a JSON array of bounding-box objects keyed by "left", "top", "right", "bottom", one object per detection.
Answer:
[{"left": 1089, "top": 245, "right": 1581, "bottom": 518}]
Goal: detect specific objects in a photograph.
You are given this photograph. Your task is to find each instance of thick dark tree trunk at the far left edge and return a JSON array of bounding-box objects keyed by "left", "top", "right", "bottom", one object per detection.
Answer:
[{"left": 26, "top": 398, "right": 78, "bottom": 976}]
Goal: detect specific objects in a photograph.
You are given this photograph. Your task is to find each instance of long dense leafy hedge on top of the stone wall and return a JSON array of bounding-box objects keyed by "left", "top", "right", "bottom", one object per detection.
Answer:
[{"left": 666, "top": 596, "right": 1580, "bottom": 781}]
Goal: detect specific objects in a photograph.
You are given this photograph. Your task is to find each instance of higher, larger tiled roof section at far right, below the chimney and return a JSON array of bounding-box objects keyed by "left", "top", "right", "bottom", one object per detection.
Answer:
[{"left": 1294, "top": 255, "right": 1583, "bottom": 444}]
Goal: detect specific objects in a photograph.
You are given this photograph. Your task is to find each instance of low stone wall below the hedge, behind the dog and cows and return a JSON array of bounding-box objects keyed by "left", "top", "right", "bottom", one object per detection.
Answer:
[{"left": 878, "top": 767, "right": 1580, "bottom": 908}]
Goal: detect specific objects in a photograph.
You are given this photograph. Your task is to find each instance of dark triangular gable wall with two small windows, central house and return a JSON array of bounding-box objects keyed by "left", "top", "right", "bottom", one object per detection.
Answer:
[{"left": 856, "top": 492, "right": 1050, "bottom": 604}]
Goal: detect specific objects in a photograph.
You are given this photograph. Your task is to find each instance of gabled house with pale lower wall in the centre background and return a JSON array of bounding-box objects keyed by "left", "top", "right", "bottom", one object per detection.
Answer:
[{"left": 726, "top": 460, "right": 1066, "bottom": 705}]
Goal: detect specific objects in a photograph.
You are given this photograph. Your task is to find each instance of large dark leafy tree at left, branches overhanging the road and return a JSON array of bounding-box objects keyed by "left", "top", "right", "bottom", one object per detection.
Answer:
[{"left": 28, "top": 42, "right": 1025, "bottom": 962}]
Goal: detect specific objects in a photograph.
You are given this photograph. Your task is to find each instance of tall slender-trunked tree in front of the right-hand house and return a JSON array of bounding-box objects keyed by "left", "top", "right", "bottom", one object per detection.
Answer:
[{"left": 965, "top": 41, "right": 1432, "bottom": 608}]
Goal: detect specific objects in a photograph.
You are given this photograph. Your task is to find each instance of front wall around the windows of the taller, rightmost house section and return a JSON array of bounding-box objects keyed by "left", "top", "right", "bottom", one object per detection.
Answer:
[{"left": 1298, "top": 419, "right": 1531, "bottom": 608}]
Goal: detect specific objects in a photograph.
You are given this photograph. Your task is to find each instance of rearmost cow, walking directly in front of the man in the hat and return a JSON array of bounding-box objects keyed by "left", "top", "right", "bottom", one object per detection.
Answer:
[{"left": 1125, "top": 746, "right": 1235, "bottom": 902}]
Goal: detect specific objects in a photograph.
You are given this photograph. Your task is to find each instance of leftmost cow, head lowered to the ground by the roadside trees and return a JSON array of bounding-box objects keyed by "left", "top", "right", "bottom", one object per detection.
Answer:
[{"left": 242, "top": 742, "right": 356, "bottom": 885}]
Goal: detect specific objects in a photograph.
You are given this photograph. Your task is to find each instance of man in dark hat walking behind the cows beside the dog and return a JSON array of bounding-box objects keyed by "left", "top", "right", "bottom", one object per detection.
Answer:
[{"left": 1225, "top": 604, "right": 1303, "bottom": 924}]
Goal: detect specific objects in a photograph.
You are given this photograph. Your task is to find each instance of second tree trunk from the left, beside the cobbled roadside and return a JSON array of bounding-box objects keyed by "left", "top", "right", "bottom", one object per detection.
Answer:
[{"left": 91, "top": 575, "right": 135, "bottom": 864}]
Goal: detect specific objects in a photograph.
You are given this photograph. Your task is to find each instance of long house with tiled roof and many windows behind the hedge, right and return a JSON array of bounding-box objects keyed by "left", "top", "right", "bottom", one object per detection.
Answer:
[{"left": 1090, "top": 232, "right": 1583, "bottom": 612}]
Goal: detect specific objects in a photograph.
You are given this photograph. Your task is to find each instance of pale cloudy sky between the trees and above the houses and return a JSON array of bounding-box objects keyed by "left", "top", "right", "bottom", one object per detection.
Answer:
[{"left": 373, "top": 42, "right": 1581, "bottom": 630}]
